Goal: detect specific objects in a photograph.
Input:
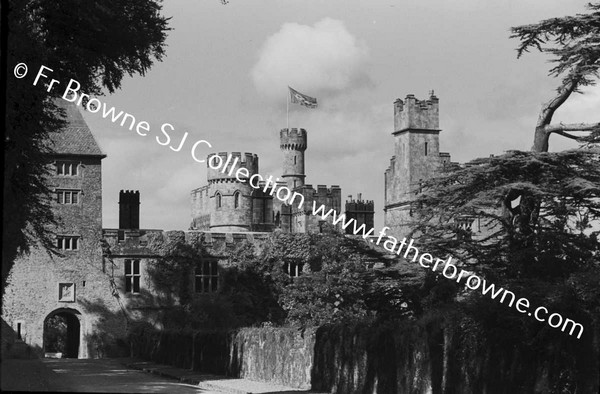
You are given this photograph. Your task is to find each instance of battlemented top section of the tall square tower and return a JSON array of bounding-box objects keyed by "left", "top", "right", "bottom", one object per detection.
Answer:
[{"left": 394, "top": 91, "right": 440, "bottom": 134}]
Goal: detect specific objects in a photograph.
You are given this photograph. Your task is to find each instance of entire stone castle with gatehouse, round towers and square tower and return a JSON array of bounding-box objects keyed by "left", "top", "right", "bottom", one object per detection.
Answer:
[{"left": 2, "top": 94, "right": 450, "bottom": 358}]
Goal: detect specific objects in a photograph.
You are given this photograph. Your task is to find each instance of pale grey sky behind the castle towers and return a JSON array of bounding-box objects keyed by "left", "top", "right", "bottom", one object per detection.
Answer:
[{"left": 84, "top": 0, "right": 600, "bottom": 230}]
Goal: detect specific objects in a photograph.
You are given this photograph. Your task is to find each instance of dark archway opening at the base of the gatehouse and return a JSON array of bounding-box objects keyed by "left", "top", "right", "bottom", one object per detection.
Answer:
[{"left": 44, "top": 311, "right": 80, "bottom": 358}]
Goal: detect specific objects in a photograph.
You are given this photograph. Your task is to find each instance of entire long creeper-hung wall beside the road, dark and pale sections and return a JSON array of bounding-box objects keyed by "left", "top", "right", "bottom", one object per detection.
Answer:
[{"left": 130, "top": 311, "right": 600, "bottom": 394}]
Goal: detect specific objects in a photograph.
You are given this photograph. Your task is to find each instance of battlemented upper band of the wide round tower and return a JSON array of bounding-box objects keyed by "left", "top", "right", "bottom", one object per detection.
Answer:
[{"left": 206, "top": 152, "right": 258, "bottom": 183}]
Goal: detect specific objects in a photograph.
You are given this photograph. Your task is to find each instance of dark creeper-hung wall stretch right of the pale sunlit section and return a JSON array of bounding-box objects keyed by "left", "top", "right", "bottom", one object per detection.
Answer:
[{"left": 311, "top": 311, "right": 600, "bottom": 394}]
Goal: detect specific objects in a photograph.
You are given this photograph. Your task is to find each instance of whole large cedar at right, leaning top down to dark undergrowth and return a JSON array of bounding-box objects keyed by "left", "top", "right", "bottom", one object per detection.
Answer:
[{"left": 404, "top": 4, "right": 600, "bottom": 392}]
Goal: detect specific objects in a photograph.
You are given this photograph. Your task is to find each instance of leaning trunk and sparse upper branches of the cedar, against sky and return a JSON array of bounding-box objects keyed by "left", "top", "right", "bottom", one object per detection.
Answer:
[{"left": 511, "top": 3, "right": 600, "bottom": 152}]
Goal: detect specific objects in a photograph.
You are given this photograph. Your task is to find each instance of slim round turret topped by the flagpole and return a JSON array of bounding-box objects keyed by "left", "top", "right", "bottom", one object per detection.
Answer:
[{"left": 279, "top": 129, "right": 306, "bottom": 190}]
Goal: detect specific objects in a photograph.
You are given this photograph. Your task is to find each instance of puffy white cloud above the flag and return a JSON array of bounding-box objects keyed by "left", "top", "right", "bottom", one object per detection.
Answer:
[{"left": 252, "top": 18, "right": 371, "bottom": 99}]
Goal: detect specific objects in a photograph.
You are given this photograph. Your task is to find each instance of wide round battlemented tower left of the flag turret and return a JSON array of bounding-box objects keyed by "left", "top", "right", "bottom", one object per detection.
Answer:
[{"left": 206, "top": 152, "right": 258, "bottom": 232}]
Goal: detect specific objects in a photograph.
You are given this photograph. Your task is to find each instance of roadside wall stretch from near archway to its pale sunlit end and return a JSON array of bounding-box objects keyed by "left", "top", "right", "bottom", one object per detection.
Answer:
[{"left": 129, "top": 326, "right": 315, "bottom": 389}]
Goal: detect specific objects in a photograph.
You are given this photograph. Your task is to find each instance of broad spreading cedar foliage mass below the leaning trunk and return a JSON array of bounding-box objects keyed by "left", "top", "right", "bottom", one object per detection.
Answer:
[{"left": 414, "top": 150, "right": 600, "bottom": 278}]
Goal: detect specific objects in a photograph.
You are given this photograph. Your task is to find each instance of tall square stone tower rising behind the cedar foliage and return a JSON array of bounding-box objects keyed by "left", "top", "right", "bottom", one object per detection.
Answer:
[{"left": 384, "top": 91, "right": 450, "bottom": 237}]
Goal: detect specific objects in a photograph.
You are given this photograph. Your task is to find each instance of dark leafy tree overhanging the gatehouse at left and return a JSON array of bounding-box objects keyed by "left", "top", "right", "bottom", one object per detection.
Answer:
[{"left": 1, "top": 0, "right": 169, "bottom": 290}]
